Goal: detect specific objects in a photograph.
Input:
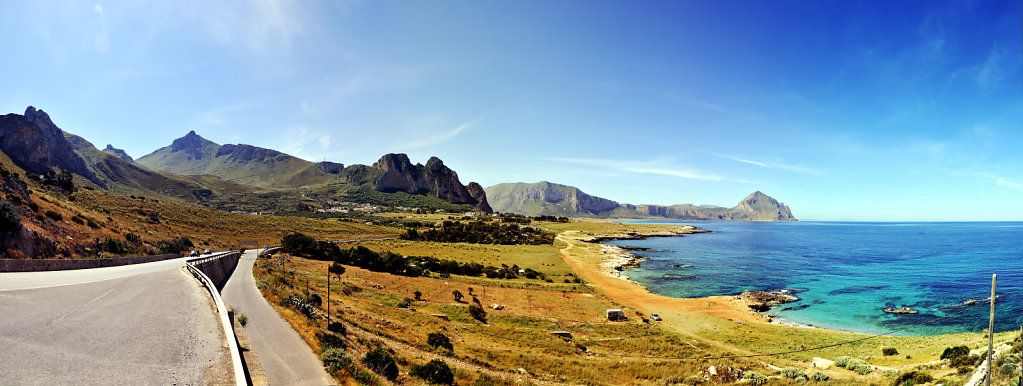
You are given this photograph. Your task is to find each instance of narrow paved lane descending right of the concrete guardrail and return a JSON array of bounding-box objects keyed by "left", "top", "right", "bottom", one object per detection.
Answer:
[{"left": 221, "top": 250, "right": 333, "bottom": 386}]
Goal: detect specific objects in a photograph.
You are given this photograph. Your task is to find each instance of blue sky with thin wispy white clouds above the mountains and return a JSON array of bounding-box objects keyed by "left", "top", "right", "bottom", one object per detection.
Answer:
[{"left": 0, "top": 0, "right": 1023, "bottom": 220}]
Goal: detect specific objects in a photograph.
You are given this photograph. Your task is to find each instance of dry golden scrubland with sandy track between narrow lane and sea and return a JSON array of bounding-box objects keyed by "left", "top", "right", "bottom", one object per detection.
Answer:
[{"left": 255, "top": 215, "right": 1018, "bottom": 385}]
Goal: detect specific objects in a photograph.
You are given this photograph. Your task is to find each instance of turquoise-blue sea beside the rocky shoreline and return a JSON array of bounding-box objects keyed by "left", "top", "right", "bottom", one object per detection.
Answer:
[{"left": 608, "top": 221, "right": 1023, "bottom": 335}]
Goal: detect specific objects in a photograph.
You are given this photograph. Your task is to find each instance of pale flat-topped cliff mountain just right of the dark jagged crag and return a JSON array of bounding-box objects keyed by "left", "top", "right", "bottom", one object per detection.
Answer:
[{"left": 487, "top": 181, "right": 621, "bottom": 217}]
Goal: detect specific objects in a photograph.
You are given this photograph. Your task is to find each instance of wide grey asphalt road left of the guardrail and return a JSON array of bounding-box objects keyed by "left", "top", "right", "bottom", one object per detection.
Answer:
[{"left": 0, "top": 266, "right": 230, "bottom": 385}]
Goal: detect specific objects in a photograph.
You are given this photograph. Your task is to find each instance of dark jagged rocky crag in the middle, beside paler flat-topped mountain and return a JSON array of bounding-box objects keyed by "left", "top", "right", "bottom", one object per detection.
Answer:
[{"left": 370, "top": 154, "right": 491, "bottom": 212}]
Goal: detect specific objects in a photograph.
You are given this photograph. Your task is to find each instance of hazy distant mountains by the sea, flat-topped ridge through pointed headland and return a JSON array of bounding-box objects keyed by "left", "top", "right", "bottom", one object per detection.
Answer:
[{"left": 486, "top": 181, "right": 796, "bottom": 221}]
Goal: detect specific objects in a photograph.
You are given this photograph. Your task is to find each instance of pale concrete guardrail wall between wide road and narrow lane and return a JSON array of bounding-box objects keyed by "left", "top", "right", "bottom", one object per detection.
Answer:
[{"left": 185, "top": 251, "right": 249, "bottom": 386}]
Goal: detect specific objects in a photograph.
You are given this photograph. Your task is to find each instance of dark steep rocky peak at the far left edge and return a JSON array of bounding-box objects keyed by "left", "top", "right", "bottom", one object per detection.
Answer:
[{"left": 0, "top": 105, "right": 102, "bottom": 185}]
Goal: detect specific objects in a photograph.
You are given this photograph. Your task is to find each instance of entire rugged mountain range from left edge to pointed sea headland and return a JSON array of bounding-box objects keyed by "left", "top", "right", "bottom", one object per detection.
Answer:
[{"left": 0, "top": 106, "right": 795, "bottom": 221}]
